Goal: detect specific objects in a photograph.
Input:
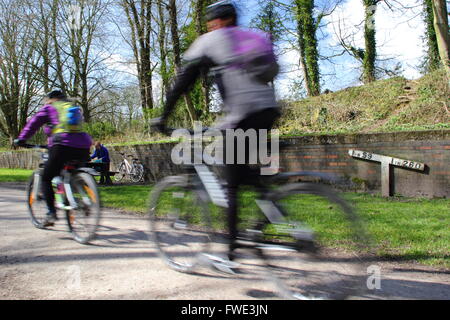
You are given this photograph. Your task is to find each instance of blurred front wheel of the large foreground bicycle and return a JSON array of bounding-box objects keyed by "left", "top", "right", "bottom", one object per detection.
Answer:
[{"left": 149, "top": 176, "right": 211, "bottom": 272}]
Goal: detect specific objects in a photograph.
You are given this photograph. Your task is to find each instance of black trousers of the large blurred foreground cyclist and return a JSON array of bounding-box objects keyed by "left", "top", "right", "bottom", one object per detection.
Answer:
[{"left": 225, "top": 108, "right": 280, "bottom": 249}]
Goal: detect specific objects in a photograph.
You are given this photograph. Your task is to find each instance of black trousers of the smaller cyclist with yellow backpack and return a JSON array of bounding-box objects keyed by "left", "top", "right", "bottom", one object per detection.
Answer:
[{"left": 42, "top": 144, "right": 90, "bottom": 213}]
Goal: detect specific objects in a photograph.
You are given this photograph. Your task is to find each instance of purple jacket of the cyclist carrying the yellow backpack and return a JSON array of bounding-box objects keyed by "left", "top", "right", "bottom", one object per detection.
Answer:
[{"left": 19, "top": 104, "right": 92, "bottom": 149}]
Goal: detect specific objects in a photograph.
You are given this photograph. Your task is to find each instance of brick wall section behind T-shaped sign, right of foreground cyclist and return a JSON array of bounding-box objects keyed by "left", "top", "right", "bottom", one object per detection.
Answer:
[{"left": 281, "top": 130, "right": 450, "bottom": 197}]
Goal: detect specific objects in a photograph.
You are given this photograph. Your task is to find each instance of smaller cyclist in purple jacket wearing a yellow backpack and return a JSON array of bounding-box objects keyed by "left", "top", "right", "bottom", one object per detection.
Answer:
[{"left": 15, "top": 90, "right": 92, "bottom": 227}]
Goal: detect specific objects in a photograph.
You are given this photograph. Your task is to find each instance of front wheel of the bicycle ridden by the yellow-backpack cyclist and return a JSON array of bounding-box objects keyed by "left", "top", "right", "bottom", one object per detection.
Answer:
[{"left": 27, "top": 171, "right": 48, "bottom": 229}]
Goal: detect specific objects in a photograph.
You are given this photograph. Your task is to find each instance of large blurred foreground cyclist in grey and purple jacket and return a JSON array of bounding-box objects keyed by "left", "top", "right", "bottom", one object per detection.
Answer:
[{"left": 153, "top": 1, "right": 280, "bottom": 260}]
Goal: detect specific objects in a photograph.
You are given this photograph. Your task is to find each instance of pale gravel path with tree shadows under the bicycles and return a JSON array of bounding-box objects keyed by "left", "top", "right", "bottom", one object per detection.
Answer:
[{"left": 0, "top": 184, "right": 450, "bottom": 300}]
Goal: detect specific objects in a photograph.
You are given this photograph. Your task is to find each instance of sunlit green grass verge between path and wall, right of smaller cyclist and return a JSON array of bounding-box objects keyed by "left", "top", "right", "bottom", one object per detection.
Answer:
[{"left": 100, "top": 186, "right": 450, "bottom": 269}]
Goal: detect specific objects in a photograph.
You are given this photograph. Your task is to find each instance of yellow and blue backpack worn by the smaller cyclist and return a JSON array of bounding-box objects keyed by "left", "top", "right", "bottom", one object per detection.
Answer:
[{"left": 52, "top": 101, "right": 84, "bottom": 134}]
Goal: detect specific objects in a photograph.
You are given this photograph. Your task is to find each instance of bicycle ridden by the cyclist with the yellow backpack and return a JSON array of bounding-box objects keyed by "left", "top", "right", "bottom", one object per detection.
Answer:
[{"left": 20, "top": 144, "right": 101, "bottom": 244}]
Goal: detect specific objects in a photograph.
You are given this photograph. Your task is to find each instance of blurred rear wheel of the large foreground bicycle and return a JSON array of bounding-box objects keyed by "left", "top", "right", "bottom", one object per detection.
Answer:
[{"left": 261, "top": 183, "right": 369, "bottom": 300}]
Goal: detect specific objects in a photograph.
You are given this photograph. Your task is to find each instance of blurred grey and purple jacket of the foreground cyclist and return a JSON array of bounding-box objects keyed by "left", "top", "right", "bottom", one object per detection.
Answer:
[{"left": 162, "top": 27, "right": 278, "bottom": 129}]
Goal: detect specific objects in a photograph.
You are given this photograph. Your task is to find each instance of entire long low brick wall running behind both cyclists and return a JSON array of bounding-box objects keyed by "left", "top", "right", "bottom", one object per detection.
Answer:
[{"left": 0, "top": 130, "right": 450, "bottom": 197}]
